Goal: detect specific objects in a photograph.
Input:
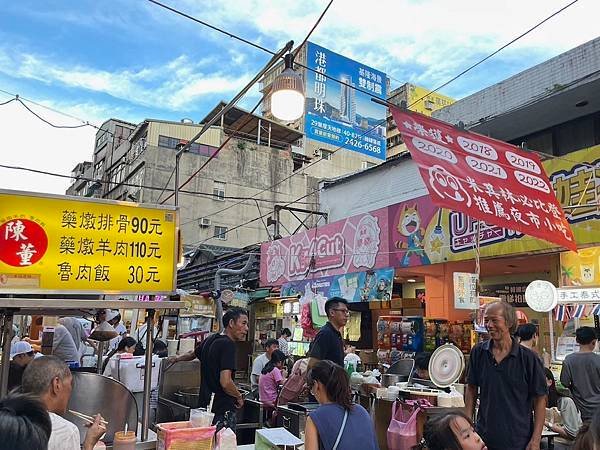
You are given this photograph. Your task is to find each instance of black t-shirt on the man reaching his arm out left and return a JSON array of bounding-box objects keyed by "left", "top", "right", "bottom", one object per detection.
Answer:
[{"left": 195, "top": 334, "right": 235, "bottom": 415}]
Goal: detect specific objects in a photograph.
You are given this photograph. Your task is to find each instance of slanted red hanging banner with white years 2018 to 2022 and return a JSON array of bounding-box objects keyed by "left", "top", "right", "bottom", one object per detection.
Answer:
[{"left": 390, "top": 107, "right": 577, "bottom": 251}]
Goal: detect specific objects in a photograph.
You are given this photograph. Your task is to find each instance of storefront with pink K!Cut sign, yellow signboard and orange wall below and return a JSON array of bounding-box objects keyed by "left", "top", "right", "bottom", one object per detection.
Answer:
[{"left": 260, "top": 147, "right": 600, "bottom": 368}]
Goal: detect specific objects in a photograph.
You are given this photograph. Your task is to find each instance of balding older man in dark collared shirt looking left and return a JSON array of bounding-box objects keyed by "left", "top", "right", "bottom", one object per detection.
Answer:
[{"left": 465, "top": 302, "right": 548, "bottom": 450}]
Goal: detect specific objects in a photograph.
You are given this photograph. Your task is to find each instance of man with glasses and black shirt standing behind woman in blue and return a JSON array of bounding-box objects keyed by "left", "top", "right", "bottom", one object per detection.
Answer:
[{"left": 308, "top": 297, "right": 350, "bottom": 368}]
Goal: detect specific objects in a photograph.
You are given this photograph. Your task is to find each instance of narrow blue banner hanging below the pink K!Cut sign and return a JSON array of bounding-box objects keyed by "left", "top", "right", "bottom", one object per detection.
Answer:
[{"left": 281, "top": 267, "right": 394, "bottom": 303}]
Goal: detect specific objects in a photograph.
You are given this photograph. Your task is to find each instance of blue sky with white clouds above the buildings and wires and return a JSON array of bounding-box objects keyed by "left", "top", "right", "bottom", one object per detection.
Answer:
[{"left": 0, "top": 0, "right": 600, "bottom": 193}]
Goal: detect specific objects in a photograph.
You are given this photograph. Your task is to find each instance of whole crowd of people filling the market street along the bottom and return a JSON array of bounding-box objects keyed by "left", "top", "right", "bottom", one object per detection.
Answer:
[{"left": 0, "top": 298, "right": 600, "bottom": 450}]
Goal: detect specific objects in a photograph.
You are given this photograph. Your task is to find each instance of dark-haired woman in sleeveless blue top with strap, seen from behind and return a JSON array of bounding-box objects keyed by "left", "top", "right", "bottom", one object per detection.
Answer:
[{"left": 304, "top": 360, "right": 379, "bottom": 450}]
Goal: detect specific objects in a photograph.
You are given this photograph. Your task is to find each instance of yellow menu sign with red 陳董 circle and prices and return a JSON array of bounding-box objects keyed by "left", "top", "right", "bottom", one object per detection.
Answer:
[{"left": 0, "top": 190, "right": 179, "bottom": 295}]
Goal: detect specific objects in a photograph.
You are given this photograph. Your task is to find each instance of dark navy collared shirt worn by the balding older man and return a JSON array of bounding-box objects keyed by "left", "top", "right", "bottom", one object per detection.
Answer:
[{"left": 467, "top": 339, "right": 548, "bottom": 450}]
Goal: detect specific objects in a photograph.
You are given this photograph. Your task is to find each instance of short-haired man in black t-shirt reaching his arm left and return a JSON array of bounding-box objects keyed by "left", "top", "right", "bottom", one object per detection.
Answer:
[{"left": 171, "top": 308, "right": 248, "bottom": 431}]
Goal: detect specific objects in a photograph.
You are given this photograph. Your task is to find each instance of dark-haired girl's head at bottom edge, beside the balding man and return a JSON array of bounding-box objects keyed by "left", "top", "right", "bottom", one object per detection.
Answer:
[{"left": 417, "top": 412, "right": 487, "bottom": 450}]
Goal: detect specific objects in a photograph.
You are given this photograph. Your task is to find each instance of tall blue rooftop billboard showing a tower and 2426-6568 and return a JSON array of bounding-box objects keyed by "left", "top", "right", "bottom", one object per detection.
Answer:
[{"left": 304, "top": 42, "right": 387, "bottom": 160}]
